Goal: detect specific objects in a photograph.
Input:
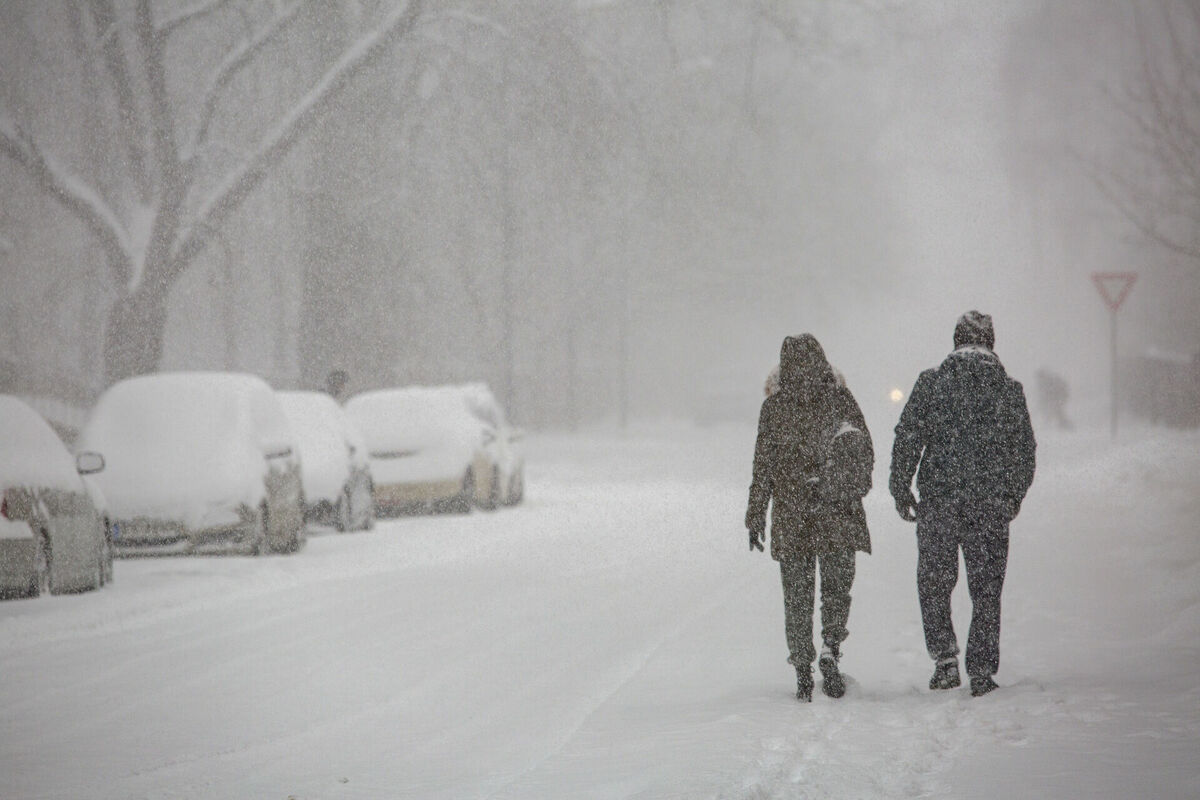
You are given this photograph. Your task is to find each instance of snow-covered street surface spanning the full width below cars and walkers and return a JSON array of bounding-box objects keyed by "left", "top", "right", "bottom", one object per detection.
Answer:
[{"left": 0, "top": 428, "right": 1200, "bottom": 800}]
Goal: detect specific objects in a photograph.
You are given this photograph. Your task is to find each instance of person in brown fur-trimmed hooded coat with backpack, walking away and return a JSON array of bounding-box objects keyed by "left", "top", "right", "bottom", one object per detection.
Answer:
[{"left": 745, "top": 333, "right": 875, "bottom": 702}]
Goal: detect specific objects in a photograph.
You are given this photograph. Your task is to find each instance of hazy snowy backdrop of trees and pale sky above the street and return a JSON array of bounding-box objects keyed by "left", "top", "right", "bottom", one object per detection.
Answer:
[{"left": 0, "top": 0, "right": 1200, "bottom": 441}]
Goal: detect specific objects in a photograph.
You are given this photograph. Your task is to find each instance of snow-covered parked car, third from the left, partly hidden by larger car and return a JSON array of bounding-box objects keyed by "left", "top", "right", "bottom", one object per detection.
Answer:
[{"left": 276, "top": 391, "right": 374, "bottom": 530}]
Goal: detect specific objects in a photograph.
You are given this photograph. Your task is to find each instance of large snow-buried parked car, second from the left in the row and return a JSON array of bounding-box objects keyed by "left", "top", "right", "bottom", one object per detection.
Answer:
[{"left": 79, "top": 372, "right": 305, "bottom": 554}]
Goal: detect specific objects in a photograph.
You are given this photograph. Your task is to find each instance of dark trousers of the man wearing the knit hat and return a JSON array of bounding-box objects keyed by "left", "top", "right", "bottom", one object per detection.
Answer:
[{"left": 917, "top": 499, "right": 1008, "bottom": 676}]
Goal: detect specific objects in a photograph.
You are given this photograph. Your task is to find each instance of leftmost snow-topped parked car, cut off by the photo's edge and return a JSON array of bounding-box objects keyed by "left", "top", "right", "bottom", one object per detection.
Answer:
[{"left": 0, "top": 395, "right": 112, "bottom": 596}]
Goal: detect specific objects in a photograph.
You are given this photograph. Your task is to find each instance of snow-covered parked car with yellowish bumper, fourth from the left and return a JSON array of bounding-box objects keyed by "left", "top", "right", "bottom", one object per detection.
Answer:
[{"left": 346, "top": 386, "right": 493, "bottom": 515}]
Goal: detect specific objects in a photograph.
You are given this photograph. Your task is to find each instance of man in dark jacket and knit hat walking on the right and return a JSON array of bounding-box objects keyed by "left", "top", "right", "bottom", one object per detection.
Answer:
[{"left": 888, "top": 311, "right": 1037, "bottom": 697}]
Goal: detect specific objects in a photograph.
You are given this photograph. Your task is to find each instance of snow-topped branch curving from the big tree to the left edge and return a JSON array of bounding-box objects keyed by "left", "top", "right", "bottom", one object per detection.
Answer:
[{"left": 0, "top": 115, "right": 132, "bottom": 284}]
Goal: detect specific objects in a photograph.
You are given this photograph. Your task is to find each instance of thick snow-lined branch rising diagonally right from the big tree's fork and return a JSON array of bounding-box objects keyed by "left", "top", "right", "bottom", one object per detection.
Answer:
[{"left": 170, "top": 0, "right": 422, "bottom": 277}]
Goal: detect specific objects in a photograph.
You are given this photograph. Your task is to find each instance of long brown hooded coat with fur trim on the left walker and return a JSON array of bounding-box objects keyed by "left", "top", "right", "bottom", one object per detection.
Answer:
[{"left": 746, "top": 333, "right": 875, "bottom": 561}]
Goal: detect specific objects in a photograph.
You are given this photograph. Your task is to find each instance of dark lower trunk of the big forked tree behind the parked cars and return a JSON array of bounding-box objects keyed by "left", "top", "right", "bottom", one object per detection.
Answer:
[{"left": 104, "top": 284, "right": 169, "bottom": 386}]
